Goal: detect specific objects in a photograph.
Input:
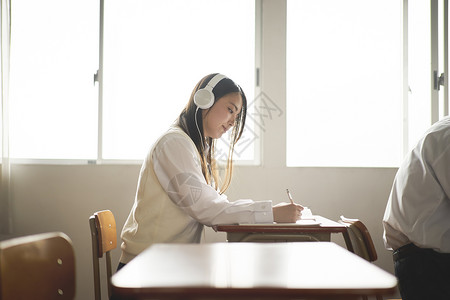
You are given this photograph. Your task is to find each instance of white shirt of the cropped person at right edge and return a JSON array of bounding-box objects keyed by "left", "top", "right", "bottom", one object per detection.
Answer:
[{"left": 383, "top": 118, "right": 450, "bottom": 253}]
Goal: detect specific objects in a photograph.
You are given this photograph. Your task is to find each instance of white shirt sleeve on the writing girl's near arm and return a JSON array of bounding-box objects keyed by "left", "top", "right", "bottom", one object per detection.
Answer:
[{"left": 152, "top": 133, "right": 273, "bottom": 226}]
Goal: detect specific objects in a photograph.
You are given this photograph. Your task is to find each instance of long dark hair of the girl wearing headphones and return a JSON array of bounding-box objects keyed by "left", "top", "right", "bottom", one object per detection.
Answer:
[{"left": 178, "top": 73, "right": 247, "bottom": 194}]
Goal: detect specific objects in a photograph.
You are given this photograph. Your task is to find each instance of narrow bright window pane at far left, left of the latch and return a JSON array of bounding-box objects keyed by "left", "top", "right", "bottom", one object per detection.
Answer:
[{"left": 10, "top": 0, "right": 99, "bottom": 158}]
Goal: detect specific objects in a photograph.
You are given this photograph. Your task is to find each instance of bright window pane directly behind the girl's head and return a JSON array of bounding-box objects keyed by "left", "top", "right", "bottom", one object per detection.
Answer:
[{"left": 103, "top": 0, "right": 255, "bottom": 159}]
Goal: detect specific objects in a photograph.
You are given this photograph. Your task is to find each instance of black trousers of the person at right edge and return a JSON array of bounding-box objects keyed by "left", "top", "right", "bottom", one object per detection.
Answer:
[{"left": 394, "top": 244, "right": 450, "bottom": 300}]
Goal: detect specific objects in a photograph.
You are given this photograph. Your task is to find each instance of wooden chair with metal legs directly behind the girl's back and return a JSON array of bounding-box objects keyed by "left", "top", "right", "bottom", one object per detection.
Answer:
[{"left": 89, "top": 210, "right": 117, "bottom": 300}]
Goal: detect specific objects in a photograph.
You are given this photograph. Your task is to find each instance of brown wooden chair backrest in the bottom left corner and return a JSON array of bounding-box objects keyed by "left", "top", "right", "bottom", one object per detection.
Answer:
[{"left": 0, "top": 232, "right": 75, "bottom": 300}]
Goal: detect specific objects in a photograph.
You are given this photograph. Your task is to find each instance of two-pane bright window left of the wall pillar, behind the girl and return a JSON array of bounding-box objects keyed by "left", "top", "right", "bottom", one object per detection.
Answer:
[{"left": 10, "top": 0, "right": 259, "bottom": 161}]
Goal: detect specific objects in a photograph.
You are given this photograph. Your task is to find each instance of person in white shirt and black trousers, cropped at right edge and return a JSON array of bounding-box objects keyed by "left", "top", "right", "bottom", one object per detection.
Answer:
[{"left": 383, "top": 117, "right": 450, "bottom": 300}]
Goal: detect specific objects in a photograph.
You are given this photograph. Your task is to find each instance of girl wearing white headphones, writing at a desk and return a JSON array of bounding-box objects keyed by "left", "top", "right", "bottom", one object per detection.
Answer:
[{"left": 119, "top": 74, "right": 303, "bottom": 268}]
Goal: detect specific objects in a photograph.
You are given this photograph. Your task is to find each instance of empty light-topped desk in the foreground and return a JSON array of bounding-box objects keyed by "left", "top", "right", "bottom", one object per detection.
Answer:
[{"left": 111, "top": 242, "right": 397, "bottom": 299}]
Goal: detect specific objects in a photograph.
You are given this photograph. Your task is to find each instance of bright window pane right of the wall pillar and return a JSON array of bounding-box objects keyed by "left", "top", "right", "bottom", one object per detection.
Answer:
[{"left": 287, "top": 0, "right": 402, "bottom": 167}]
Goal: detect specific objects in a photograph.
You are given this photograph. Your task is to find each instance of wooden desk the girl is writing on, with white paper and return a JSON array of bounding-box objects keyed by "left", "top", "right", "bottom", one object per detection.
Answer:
[{"left": 213, "top": 216, "right": 347, "bottom": 242}]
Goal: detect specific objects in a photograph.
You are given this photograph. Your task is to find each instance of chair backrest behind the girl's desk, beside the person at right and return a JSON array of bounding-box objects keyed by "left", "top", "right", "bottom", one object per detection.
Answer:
[{"left": 338, "top": 216, "right": 378, "bottom": 262}]
